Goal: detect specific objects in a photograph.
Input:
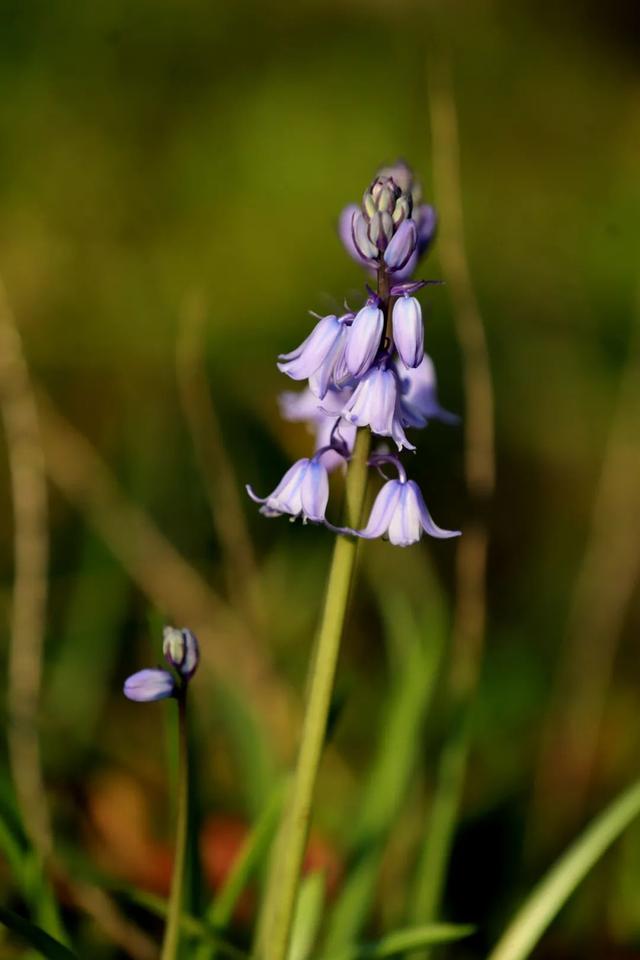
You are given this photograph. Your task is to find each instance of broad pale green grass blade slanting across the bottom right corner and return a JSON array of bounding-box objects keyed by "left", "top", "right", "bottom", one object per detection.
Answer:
[{"left": 489, "top": 780, "right": 640, "bottom": 960}]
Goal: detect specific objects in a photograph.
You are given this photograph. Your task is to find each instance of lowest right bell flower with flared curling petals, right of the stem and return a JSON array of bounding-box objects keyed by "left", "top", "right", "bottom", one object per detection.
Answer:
[{"left": 356, "top": 471, "right": 460, "bottom": 547}]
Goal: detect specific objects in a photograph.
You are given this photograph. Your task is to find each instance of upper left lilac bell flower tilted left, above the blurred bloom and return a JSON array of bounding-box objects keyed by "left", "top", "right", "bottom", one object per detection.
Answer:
[{"left": 278, "top": 314, "right": 352, "bottom": 398}]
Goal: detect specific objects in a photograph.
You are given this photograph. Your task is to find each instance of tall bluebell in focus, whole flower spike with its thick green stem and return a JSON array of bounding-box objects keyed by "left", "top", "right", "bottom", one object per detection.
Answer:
[{"left": 247, "top": 163, "right": 459, "bottom": 960}]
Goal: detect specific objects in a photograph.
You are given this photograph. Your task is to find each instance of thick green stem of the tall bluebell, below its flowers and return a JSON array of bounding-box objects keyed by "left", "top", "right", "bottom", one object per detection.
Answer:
[{"left": 257, "top": 430, "right": 370, "bottom": 960}]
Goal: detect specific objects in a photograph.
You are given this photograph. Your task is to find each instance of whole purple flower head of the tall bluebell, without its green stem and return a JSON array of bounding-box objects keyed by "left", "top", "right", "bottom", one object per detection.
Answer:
[{"left": 247, "top": 163, "right": 459, "bottom": 546}]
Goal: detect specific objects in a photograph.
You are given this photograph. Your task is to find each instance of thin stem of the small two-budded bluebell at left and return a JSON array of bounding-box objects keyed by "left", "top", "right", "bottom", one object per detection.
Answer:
[{"left": 161, "top": 687, "right": 189, "bottom": 960}]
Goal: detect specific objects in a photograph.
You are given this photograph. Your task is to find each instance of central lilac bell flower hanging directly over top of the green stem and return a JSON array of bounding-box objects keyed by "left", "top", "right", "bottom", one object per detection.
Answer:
[{"left": 342, "top": 363, "right": 415, "bottom": 450}]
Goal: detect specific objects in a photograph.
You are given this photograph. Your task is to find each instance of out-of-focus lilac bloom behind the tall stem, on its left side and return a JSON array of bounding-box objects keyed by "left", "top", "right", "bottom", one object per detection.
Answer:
[{"left": 279, "top": 387, "right": 357, "bottom": 472}]
